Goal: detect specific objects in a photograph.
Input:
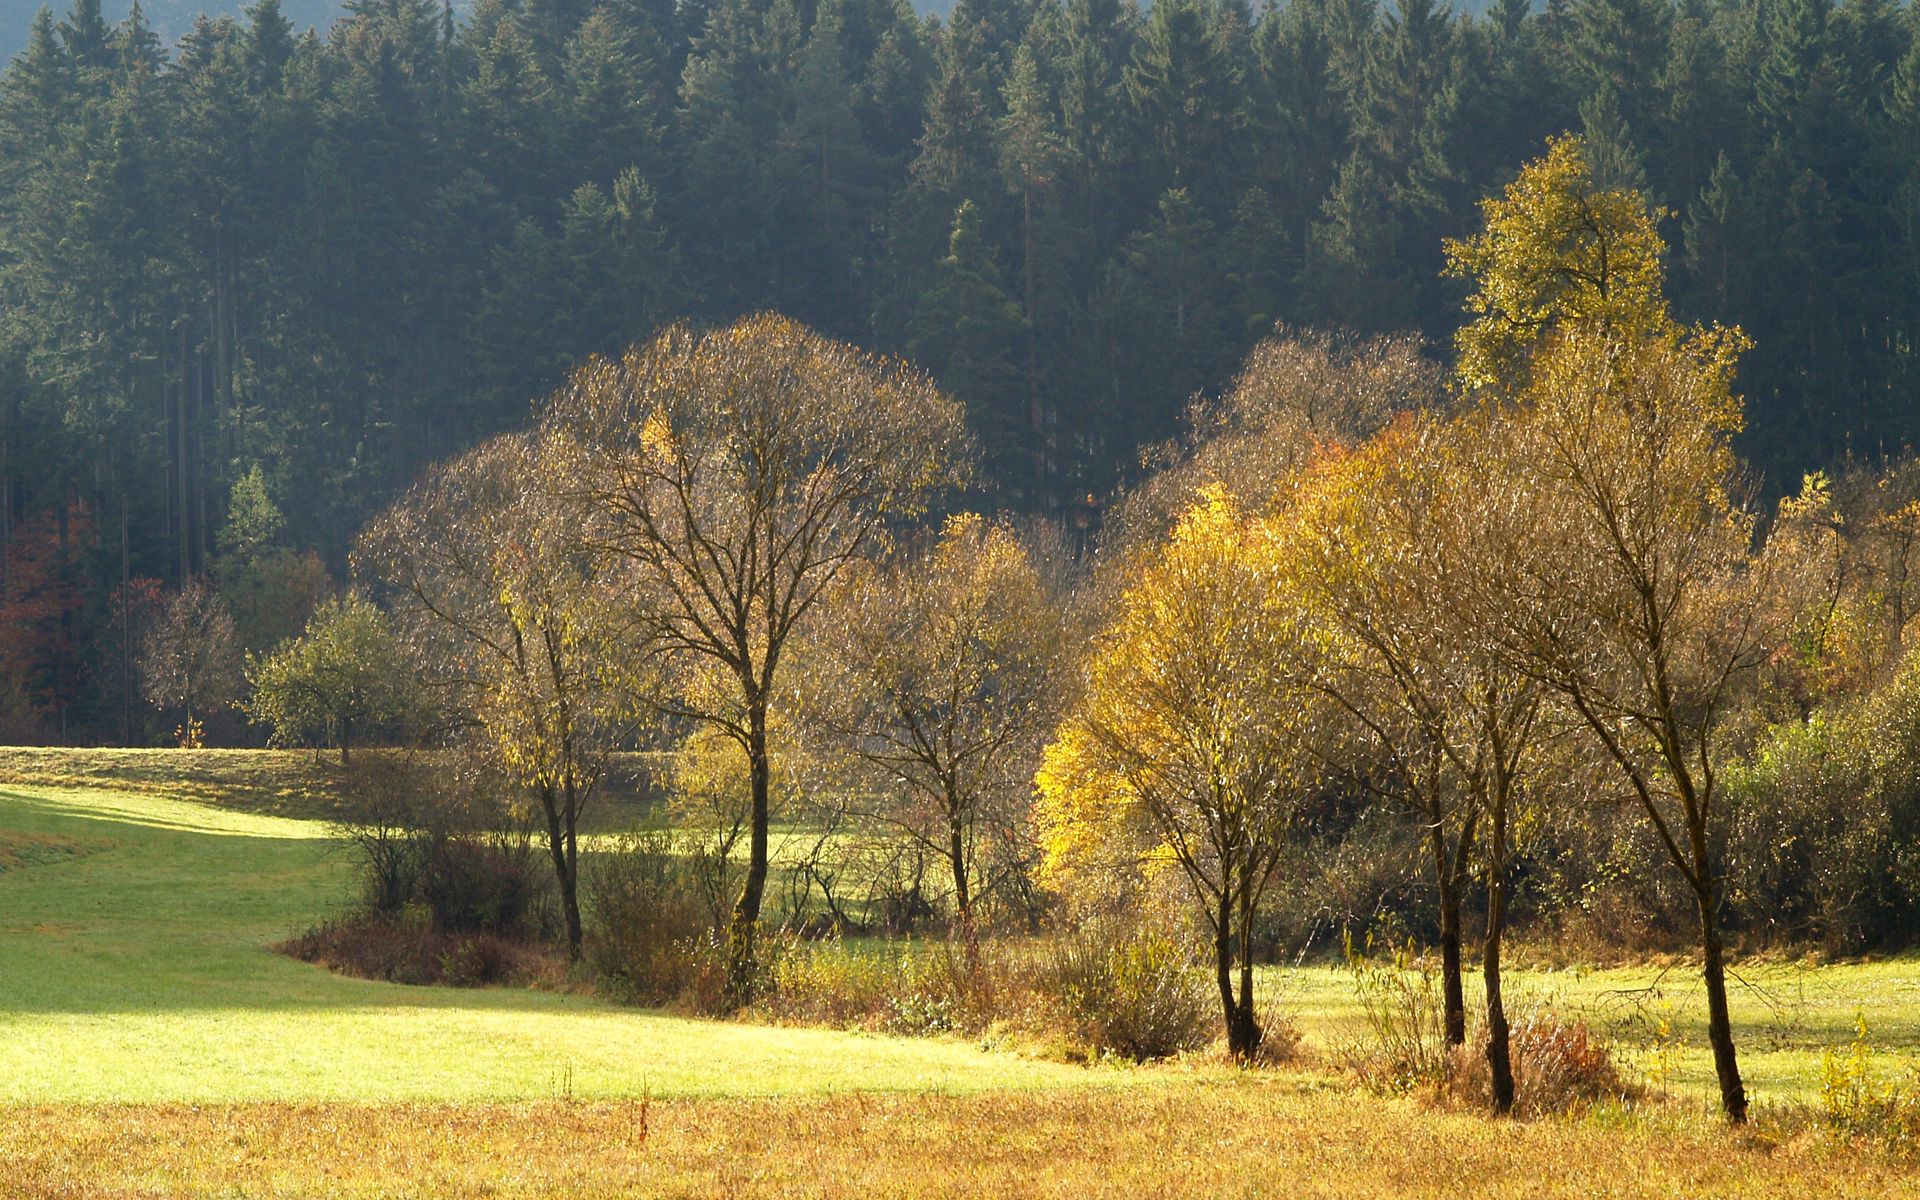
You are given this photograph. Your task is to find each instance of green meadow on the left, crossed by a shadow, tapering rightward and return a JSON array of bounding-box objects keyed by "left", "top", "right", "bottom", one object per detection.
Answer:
[{"left": 0, "top": 787, "right": 1123, "bottom": 1104}]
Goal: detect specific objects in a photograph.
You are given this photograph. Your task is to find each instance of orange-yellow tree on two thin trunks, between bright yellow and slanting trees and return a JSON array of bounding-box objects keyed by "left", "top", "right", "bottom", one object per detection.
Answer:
[{"left": 1292, "top": 415, "right": 1548, "bottom": 1112}]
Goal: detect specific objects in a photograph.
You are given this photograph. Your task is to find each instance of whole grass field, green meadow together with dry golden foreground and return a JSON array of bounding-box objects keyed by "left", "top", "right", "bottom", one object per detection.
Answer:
[{"left": 0, "top": 760, "right": 1920, "bottom": 1196}]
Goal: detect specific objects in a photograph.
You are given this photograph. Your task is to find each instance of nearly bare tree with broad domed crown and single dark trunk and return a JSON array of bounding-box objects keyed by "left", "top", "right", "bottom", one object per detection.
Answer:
[{"left": 545, "top": 315, "right": 964, "bottom": 1002}]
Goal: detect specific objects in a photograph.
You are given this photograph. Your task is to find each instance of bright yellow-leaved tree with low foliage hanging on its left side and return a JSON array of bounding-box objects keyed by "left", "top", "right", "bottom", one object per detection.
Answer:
[{"left": 1035, "top": 488, "right": 1327, "bottom": 1058}]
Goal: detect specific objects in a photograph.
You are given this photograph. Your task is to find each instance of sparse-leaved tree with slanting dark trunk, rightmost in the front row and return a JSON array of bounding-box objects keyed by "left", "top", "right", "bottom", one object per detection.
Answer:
[{"left": 1494, "top": 322, "right": 1768, "bottom": 1121}]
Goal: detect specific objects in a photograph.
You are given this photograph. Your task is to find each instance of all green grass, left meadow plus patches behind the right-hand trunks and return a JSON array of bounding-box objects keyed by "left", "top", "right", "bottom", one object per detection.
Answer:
[{"left": 11, "top": 764, "right": 1920, "bottom": 1106}]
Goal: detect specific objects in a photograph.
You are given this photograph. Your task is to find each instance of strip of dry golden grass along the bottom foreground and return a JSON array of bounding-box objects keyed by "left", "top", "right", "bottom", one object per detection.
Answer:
[{"left": 0, "top": 1073, "right": 1920, "bottom": 1200}]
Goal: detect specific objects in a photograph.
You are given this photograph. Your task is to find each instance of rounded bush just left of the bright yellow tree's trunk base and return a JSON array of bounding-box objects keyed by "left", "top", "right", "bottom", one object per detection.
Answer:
[{"left": 1048, "top": 916, "right": 1219, "bottom": 1062}]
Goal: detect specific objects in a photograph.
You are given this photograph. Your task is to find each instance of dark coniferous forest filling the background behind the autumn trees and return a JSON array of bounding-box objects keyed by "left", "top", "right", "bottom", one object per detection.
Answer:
[{"left": 0, "top": 0, "right": 1920, "bottom": 743}]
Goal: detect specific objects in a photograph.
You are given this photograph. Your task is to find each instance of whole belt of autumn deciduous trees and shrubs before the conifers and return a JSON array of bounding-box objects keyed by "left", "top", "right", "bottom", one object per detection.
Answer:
[{"left": 243, "top": 138, "right": 1920, "bottom": 1121}]
